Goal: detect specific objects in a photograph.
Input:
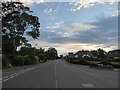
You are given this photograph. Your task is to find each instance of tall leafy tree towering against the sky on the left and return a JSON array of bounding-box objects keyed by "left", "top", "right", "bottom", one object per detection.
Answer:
[{"left": 1, "top": 2, "right": 40, "bottom": 54}]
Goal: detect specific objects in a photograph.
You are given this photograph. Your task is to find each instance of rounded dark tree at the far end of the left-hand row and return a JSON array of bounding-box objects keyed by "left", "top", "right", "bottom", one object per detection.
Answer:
[{"left": 46, "top": 48, "right": 58, "bottom": 59}]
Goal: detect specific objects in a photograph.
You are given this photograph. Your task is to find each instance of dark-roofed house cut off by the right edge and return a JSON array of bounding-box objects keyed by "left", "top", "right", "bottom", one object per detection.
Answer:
[{"left": 107, "top": 49, "right": 120, "bottom": 59}]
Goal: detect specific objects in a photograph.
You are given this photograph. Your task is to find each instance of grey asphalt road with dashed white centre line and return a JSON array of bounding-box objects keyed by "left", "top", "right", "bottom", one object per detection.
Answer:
[{"left": 3, "top": 60, "right": 118, "bottom": 88}]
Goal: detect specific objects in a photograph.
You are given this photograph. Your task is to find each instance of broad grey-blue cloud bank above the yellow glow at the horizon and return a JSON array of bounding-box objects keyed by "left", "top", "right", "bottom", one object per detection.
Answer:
[{"left": 42, "top": 16, "right": 118, "bottom": 47}]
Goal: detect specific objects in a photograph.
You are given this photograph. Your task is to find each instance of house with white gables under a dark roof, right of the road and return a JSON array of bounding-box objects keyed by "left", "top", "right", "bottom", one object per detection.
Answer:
[{"left": 74, "top": 50, "right": 94, "bottom": 58}]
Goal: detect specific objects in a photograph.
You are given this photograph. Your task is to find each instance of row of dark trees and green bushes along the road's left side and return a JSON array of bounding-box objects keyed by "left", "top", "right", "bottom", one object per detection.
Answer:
[{"left": 2, "top": 47, "right": 58, "bottom": 68}]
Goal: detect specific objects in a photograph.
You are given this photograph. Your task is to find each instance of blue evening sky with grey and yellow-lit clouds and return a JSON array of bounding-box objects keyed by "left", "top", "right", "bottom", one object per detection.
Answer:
[{"left": 6, "top": 0, "right": 119, "bottom": 55}]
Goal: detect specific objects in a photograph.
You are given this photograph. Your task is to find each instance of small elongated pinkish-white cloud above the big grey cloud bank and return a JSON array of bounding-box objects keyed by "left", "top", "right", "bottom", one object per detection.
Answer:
[{"left": 46, "top": 22, "right": 96, "bottom": 34}]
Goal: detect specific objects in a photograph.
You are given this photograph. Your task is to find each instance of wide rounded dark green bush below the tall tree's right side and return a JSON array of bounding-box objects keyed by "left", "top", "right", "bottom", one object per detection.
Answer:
[{"left": 12, "top": 55, "right": 24, "bottom": 66}]
